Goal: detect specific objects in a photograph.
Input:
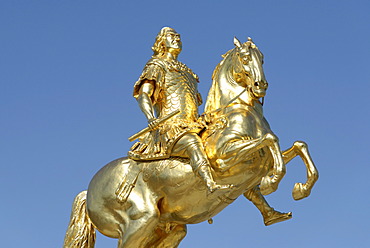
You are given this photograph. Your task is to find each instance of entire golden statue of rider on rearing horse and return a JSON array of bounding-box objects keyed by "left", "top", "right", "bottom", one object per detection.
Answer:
[{"left": 64, "top": 27, "right": 318, "bottom": 248}]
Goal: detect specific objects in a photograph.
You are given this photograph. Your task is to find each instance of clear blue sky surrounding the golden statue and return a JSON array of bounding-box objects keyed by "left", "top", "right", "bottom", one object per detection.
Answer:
[{"left": 0, "top": 0, "right": 370, "bottom": 248}]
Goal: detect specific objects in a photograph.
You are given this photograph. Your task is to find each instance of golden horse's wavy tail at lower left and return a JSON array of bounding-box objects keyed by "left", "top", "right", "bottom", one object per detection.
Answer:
[{"left": 63, "top": 190, "right": 96, "bottom": 248}]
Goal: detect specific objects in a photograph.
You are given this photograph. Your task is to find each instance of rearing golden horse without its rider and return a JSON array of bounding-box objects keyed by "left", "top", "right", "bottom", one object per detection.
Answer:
[{"left": 64, "top": 38, "right": 318, "bottom": 248}]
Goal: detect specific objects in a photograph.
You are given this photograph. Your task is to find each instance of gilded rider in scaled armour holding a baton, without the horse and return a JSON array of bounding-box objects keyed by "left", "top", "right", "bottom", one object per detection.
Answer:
[{"left": 129, "top": 27, "right": 230, "bottom": 192}]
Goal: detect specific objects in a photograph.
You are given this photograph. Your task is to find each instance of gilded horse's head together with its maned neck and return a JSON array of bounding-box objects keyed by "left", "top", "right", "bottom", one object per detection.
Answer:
[{"left": 205, "top": 38, "right": 268, "bottom": 112}]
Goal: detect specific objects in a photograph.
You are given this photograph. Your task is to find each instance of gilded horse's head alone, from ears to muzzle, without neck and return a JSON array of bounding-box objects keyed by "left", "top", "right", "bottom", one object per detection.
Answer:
[{"left": 232, "top": 38, "right": 268, "bottom": 99}]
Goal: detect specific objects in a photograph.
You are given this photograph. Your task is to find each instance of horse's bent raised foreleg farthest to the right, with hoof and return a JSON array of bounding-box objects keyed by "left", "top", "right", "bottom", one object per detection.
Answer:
[{"left": 283, "top": 141, "right": 319, "bottom": 200}]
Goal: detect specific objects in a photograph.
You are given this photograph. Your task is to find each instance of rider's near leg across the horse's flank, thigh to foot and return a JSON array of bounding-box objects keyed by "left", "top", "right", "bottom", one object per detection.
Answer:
[{"left": 171, "top": 133, "right": 230, "bottom": 193}]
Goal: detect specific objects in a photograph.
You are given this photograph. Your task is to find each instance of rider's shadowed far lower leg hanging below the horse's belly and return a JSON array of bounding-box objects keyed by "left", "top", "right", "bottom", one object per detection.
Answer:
[{"left": 244, "top": 186, "right": 292, "bottom": 226}]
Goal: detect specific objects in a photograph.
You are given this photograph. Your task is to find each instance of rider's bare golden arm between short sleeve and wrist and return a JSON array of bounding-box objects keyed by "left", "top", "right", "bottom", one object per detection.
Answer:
[{"left": 137, "top": 80, "right": 155, "bottom": 122}]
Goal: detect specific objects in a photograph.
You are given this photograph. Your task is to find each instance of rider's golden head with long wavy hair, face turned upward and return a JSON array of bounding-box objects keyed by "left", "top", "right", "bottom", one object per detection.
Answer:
[{"left": 152, "top": 27, "right": 182, "bottom": 56}]
